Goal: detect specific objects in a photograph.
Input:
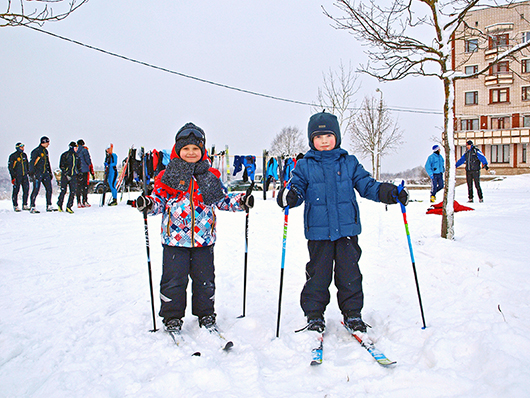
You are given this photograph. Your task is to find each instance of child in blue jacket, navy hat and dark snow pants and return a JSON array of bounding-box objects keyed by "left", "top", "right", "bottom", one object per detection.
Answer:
[{"left": 277, "top": 112, "right": 408, "bottom": 332}]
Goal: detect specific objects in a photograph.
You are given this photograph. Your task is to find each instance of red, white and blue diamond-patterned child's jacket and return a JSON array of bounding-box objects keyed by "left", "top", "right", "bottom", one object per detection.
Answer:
[{"left": 144, "top": 145, "right": 244, "bottom": 248}]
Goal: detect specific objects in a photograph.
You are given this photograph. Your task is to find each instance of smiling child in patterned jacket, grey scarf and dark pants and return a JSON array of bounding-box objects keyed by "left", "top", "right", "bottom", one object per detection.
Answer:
[{"left": 136, "top": 123, "right": 254, "bottom": 332}]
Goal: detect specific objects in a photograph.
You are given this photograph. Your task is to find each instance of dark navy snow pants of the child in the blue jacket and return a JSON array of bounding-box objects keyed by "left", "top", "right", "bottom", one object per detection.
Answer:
[{"left": 300, "top": 236, "right": 364, "bottom": 316}]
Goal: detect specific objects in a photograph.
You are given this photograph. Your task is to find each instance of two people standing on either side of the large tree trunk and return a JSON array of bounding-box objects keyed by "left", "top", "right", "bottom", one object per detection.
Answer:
[{"left": 425, "top": 140, "right": 489, "bottom": 203}]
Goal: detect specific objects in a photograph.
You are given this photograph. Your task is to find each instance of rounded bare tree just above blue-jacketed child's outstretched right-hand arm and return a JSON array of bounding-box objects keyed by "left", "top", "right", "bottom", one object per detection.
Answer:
[{"left": 351, "top": 96, "right": 403, "bottom": 180}]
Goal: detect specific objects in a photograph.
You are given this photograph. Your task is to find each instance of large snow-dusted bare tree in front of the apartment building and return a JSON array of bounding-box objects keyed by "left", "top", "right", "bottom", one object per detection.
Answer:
[{"left": 324, "top": 0, "right": 530, "bottom": 239}]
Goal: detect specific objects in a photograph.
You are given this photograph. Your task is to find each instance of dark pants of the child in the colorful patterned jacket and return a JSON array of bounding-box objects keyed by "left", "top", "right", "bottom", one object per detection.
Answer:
[{"left": 159, "top": 245, "right": 215, "bottom": 319}]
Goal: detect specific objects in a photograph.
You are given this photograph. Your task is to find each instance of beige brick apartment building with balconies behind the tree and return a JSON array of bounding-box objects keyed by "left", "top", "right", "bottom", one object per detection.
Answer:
[{"left": 452, "top": 1, "right": 530, "bottom": 174}]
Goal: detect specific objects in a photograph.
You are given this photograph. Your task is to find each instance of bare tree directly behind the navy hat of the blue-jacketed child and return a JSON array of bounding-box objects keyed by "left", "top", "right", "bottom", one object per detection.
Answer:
[{"left": 313, "top": 61, "right": 360, "bottom": 141}]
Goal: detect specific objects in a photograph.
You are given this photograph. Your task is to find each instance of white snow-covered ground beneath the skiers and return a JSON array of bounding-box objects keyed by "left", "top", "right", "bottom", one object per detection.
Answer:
[{"left": 0, "top": 175, "right": 530, "bottom": 398}]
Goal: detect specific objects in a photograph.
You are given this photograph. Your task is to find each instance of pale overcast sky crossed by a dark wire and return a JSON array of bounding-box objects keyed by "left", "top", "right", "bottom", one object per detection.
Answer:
[{"left": 0, "top": 0, "right": 443, "bottom": 172}]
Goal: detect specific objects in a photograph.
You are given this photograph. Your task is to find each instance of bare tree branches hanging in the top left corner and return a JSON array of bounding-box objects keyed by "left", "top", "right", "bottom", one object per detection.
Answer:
[{"left": 0, "top": 0, "right": 88, "bottom": 27}]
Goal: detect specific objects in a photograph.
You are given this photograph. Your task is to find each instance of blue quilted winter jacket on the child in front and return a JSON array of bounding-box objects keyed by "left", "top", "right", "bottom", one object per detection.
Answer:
[{"left": 291, "top": 148, "right": 381, "bottom": 241}]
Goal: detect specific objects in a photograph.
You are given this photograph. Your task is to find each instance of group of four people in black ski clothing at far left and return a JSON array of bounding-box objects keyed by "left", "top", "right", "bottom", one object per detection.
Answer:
[{"left": 8, "top": 136, "right": 94, "bottom": 214}]
